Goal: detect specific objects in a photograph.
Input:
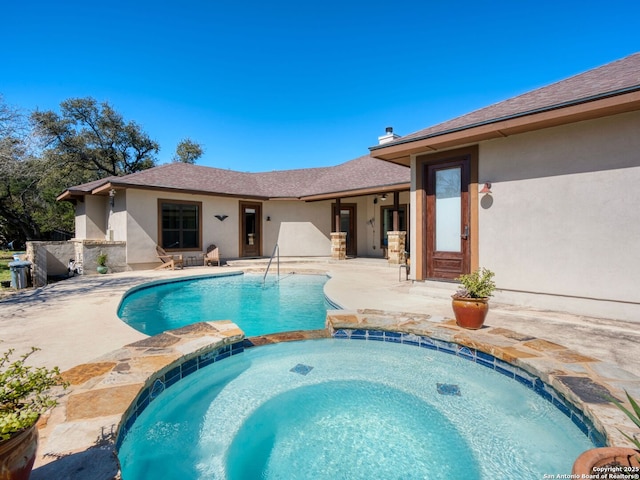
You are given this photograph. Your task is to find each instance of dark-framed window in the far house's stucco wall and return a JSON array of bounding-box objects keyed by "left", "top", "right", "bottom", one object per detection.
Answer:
[{"left": 158, "top": 200, "right": 202, "bottom": 250}]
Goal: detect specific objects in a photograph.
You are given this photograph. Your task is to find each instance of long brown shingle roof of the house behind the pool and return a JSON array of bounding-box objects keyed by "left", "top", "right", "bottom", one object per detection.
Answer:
[{"left": 58, "top": 155, "right": 411, "bottom": 200}]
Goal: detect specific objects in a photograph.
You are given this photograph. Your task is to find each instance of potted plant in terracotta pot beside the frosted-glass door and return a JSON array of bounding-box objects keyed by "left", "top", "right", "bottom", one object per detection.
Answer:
[{"left": 451, "top": 268, "right": 496, "bottom": 330}]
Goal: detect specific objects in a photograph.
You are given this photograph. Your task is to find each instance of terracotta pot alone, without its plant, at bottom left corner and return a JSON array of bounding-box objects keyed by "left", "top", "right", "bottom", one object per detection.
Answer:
[{"left": 0, "top": 425, "right": 38, "bottom": 480}]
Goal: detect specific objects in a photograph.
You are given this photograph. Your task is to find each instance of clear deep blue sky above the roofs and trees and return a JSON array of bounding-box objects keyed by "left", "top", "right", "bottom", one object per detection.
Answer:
[{"left": 0, "top": 0, "right": 640, "bottom": 172}]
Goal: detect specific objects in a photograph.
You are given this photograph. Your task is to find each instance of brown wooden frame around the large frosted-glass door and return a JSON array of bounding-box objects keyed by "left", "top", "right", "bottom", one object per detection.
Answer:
[{"left": 411, "top": 145, "right": 479, "bottom": 281}]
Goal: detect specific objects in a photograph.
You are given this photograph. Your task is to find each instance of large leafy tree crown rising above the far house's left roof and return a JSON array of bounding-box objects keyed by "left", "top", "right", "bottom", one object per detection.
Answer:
[{"left": 31, "top": 97, "right": 160, "bottom": 178}]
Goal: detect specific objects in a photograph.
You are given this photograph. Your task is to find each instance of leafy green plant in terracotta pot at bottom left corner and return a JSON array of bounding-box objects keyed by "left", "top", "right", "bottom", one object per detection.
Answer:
[{"left": 0, "top": 347, "right": 67, "bottom": 480}]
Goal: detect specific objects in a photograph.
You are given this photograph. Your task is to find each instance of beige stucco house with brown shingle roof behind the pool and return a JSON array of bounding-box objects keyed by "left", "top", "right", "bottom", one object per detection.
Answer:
[{"left": 58, "top": 155, "right": 410, "bottom": 270}]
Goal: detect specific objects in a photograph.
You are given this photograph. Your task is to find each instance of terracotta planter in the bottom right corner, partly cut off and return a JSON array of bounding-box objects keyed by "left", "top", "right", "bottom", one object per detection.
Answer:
[{"left": 571, "top": 447, "right": 640, "bottom": 478}]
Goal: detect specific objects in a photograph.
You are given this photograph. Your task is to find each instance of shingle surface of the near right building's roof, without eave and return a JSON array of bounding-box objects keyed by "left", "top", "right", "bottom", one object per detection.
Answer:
[{"left": 371, "top": 53, "right": 640, "bottom": 146}]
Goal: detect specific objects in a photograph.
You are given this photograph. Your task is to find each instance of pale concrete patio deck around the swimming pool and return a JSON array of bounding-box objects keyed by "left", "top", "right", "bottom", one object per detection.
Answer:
[{"left": 0, "top": 259, "right": 640, "bottom": 480}]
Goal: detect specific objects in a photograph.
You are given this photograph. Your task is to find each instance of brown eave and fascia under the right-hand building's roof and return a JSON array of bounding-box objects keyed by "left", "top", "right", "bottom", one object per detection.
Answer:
[{"left": 369, "top": 86, "right": 640, "bottom": 166}]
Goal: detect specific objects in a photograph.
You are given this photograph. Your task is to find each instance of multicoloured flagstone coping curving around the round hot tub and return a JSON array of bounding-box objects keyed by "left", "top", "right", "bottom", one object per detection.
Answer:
[{"left": 32, "top": 310, "right": 640, "bottom": 480}]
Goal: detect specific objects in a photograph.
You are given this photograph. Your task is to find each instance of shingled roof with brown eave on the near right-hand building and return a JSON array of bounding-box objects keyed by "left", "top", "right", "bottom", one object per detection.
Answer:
[{"left": 370, "top": 53, "right": 640, "bottom": 165}]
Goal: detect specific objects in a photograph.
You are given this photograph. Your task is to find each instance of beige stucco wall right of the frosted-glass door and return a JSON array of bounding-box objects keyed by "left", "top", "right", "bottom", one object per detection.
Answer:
[{"left": 412, "top": 112, "right": 640, "bottom": 321}]
